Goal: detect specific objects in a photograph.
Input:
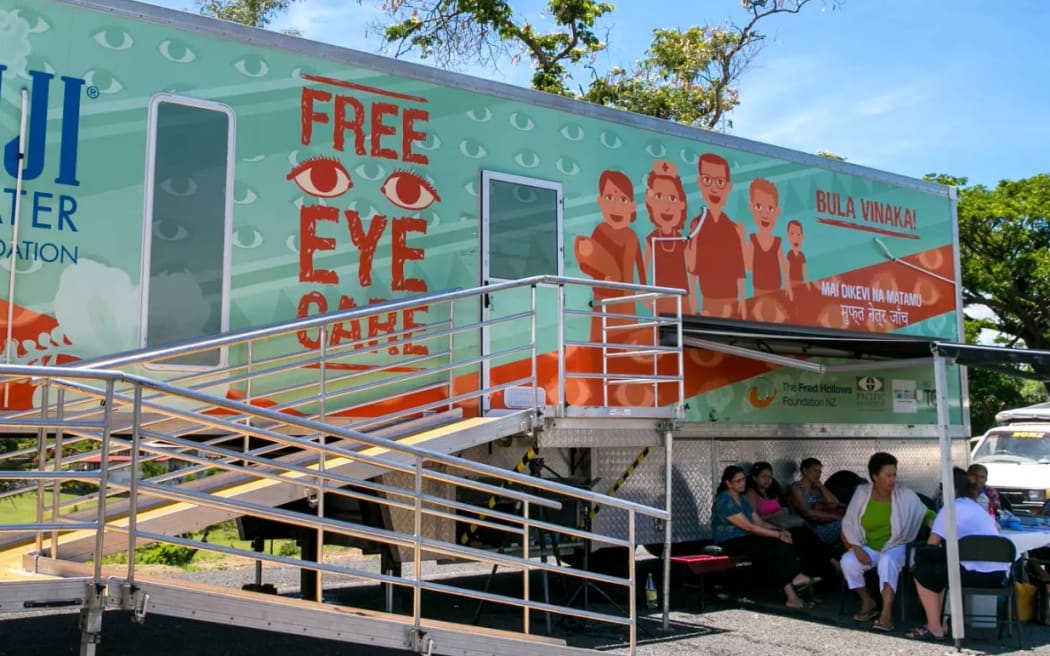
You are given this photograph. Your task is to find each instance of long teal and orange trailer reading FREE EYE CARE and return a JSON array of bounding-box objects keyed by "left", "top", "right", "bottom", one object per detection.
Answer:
[{"left": 0, "top": 2, "right": 967, "bottom": 566}]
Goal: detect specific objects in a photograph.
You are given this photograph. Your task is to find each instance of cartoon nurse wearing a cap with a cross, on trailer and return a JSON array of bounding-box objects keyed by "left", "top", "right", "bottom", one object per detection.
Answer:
[{"left": 645, "top": 160, "right": 695, "bottom": 314}]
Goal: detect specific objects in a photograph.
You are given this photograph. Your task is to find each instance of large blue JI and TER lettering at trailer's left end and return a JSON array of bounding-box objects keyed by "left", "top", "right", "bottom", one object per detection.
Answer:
[{"left": 0, "top": 64, "right": 86, "bottom": 233}]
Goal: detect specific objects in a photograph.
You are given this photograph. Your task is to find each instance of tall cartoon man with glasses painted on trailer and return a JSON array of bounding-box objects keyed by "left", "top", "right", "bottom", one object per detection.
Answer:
[{"left": 686, "top": 152, "right": 747, "bottom": 319}]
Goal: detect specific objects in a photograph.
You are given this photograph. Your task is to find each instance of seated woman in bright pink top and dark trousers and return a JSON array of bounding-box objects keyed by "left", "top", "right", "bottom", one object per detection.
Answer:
[{"left": 747, "top": 462, "right": 838, "bottom": 577}]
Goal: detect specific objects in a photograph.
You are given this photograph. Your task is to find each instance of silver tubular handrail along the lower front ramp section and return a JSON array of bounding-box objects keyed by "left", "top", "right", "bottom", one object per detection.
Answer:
[{"left": 3, "top": 367, "right": 667, "bottom": 644}]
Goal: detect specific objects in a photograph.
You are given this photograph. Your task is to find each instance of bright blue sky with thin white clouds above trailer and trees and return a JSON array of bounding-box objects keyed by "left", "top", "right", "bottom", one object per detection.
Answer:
[{"left": 141, "top": 0, "right": 1050, "bottom": 186}]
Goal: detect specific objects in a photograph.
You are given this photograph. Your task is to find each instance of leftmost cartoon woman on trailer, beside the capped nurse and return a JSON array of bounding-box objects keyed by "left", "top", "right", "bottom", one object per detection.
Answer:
[{"left": 574, "top": 171, "right": 646, "bottom": 341}]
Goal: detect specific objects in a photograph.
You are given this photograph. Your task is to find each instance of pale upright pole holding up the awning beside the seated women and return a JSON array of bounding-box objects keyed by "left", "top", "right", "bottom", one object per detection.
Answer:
[{"left": 933, "top": 351, "right": 966, "bottom": 650}]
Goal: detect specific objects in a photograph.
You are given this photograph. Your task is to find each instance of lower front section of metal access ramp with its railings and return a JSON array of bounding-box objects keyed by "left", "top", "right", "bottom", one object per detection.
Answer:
[{"left": 0, "top": 367, "right": 668, "bottom": 656}]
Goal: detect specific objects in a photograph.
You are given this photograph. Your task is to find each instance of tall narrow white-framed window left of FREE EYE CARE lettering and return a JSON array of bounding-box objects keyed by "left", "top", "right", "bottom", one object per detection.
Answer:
[{"left": 142, "top": 94, "right": 234, "bottom": 367}]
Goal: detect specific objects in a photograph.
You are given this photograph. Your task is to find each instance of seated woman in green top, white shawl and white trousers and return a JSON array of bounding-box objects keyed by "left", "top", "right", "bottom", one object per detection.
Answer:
[{"left": 842, "top": 452, "right": 933, "bottom": 631}]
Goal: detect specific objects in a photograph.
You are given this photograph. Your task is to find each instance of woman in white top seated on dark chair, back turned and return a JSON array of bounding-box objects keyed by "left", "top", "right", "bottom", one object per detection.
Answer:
[{"left": 907, "top": 467, "right": 1010, "bottom": 640}]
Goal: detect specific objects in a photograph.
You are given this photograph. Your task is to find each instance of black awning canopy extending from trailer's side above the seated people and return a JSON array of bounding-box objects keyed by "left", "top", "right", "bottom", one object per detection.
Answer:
[{"left": 668, "top": 316, "right": 1050, "bottom": 381}]
